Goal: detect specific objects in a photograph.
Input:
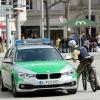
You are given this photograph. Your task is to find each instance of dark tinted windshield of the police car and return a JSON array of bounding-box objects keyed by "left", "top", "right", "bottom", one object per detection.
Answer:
[{"left": 15, "top": 48, "right": 63, "bottom": 62}]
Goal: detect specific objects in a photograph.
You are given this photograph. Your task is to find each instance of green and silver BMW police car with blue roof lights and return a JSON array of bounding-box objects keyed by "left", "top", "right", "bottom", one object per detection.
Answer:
[{"left": 1, "top": 39, "right": 77, "bottom": 96}]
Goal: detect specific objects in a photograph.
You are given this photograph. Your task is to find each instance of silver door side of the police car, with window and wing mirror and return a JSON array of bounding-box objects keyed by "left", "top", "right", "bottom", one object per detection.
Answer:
[{"left": 2, "top": 49, "right": 13, "bottom": 88}]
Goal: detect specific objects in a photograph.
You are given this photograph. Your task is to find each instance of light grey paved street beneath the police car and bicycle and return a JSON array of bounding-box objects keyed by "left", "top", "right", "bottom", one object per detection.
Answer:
[{"left": 0, "top": 52, "right": 100, "bottom": 100}]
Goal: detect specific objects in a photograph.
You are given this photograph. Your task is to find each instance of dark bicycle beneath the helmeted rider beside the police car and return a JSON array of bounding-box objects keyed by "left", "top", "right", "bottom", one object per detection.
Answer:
[{"left": 82, "top": 56, "right": 97, "bottom": 92}]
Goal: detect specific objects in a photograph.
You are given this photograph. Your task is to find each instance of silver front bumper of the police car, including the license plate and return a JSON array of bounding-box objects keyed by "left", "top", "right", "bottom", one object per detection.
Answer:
[{"left": 16, "top": 76, "right": 77, "bottom": 92}]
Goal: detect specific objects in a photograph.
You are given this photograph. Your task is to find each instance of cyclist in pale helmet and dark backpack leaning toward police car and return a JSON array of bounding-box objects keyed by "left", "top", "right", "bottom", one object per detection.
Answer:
[{"left": 68, "top": 40, "right": 100, "bottom": 90}]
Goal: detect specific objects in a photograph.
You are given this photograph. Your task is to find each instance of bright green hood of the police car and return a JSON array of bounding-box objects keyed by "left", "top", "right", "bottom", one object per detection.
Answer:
[{"left": 16, "top": 60, "right": 71, "bottom": 73}]
